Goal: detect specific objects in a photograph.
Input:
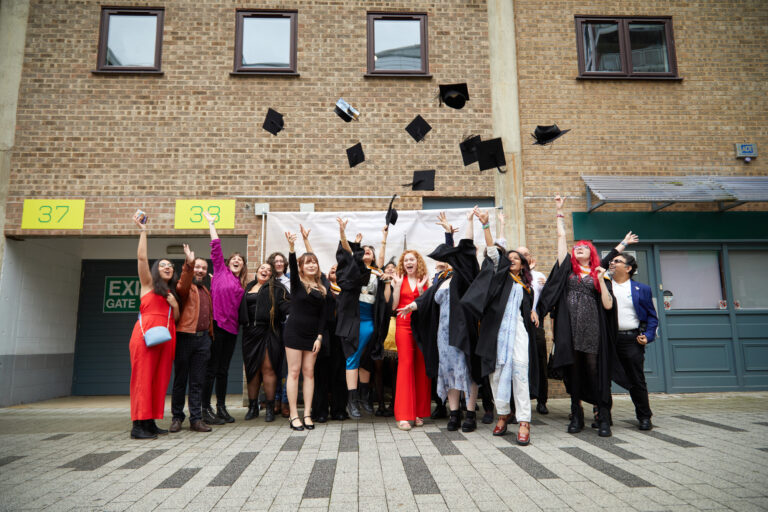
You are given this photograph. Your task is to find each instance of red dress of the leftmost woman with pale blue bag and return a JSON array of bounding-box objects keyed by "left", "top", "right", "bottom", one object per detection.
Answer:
[{"left": 129, "top": 292, "right": 176, "bottom": 420}]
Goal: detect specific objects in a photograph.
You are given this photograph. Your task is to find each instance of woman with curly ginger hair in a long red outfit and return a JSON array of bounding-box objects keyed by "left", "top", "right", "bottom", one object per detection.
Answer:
[{"left": 392, "top": 251, "right": 432, "bottom": 430}]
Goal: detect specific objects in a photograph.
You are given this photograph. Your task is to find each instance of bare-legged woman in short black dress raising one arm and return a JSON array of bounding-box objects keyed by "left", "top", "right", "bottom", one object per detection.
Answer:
[{"left": 283, "top": 233, "right": 328, "bottom": 430}]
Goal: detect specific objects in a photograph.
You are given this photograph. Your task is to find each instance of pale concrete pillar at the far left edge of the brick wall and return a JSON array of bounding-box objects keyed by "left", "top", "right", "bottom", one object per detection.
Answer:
[{"left": 0, "top": 0, "right": 29, "bottom": 288}]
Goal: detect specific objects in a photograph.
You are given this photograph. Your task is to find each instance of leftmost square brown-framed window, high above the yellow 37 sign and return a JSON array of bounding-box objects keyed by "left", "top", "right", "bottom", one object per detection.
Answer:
[{"left": 96, "top": 7, "right": 164, "bottom": 73}]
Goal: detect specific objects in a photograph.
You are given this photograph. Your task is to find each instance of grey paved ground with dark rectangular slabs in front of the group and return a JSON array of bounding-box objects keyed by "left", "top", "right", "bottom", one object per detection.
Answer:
[{"left": 0, "top": 392, "right": 768, "bottom": 511}]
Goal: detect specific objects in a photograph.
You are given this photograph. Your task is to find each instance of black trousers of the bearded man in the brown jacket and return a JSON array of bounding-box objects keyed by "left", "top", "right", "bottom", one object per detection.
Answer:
[{"left": 171, "top": 332, "right": 211, "bottom": 423}]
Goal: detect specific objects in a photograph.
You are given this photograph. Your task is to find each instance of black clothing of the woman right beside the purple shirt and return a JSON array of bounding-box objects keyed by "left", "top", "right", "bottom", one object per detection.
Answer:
[{"left": 239, "top": 280, "right": 290, "bottom": 381}]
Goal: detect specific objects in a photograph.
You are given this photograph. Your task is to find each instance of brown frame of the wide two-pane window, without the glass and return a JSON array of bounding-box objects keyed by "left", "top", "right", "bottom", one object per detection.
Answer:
[{"left": 574, "top": 15, "right": 682, "bottom": 80}]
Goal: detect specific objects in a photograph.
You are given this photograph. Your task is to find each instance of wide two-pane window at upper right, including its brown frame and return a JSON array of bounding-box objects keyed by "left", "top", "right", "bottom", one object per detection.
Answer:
[{"left": 576, "top": 16, "right": 678, "bottom": 79}]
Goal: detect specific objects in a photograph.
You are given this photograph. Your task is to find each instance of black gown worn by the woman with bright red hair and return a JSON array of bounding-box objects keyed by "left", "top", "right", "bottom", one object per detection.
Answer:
[{"left": 536, "top": 251, "right": 629, "bottom": 404}]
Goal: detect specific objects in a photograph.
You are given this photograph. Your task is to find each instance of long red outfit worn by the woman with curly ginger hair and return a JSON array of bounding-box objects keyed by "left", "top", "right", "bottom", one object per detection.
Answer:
[{"left": 395, "top": 277, "right": 432, "bottom": 421}]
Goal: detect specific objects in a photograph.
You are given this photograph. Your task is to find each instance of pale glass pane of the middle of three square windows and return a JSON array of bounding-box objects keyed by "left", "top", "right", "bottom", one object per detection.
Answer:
[{"left": 241, "top": 17, "right": 291, "bottom": 68}]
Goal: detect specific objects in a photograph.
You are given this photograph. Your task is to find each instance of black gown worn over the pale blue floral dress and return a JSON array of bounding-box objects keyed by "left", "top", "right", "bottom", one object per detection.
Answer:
[{"left": 411, "top": 239, "right": 482, "bottom": 383}]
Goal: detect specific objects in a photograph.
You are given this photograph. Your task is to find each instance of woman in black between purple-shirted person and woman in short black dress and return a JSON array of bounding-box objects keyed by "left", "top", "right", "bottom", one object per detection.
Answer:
[{"left": 240, "top": 263, "right": 290, "bottom": 422}]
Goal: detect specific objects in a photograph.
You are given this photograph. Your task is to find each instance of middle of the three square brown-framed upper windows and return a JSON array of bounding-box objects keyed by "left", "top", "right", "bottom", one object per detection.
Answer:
[{"left": 232, "top": 10, "right": 298, "bottom": 75}]
